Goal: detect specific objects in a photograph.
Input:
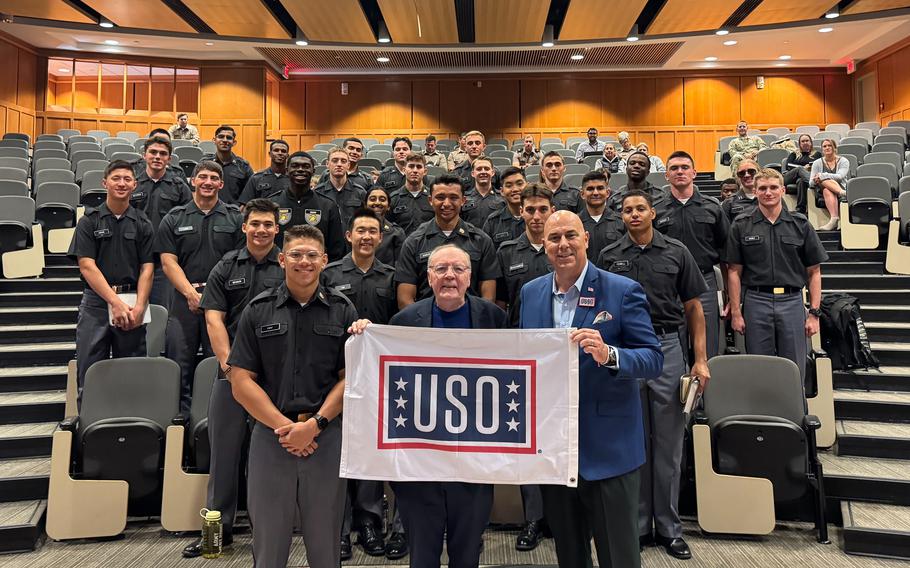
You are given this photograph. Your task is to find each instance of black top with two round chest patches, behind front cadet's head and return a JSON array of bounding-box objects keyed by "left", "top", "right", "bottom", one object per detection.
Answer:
[{"left": 272, "top": 187, "right": 347, "bottom": 261}]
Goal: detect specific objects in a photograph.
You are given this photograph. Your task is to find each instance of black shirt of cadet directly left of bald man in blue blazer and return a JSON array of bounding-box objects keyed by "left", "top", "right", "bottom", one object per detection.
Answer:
[{"left": 496, "top": 233, "right": 553, "bottom": 328}]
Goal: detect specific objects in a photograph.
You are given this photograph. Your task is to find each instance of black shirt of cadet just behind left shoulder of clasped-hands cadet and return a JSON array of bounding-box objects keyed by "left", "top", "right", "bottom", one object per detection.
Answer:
[{"left": 199, "top": 247, "right": 284, "bottom": 339}]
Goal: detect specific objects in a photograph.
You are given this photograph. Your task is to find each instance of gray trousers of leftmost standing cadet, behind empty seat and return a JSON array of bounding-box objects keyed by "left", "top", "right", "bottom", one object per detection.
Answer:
[{"left": 76, "top": 288, "right": 145, "bottom": 400}]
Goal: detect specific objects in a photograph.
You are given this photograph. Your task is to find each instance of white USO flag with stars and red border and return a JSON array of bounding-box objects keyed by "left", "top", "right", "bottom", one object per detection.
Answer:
[{"left": 341, "top": 324, "right": 578, "bottom": 486}]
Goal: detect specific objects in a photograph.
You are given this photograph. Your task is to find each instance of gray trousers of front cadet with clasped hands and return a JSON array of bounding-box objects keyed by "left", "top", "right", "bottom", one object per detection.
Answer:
[{"left": 247, "top": 417, "right": 345, "bottom": 568}]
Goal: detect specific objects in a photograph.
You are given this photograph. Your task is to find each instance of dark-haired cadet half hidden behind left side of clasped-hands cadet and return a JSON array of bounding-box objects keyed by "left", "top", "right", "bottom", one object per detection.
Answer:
[{"left": 183, "top": 197, "right": 284, "bottom": 558}]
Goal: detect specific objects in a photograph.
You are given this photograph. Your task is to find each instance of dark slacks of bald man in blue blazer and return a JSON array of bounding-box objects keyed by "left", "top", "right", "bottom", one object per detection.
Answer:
[{"left": 541, "top": 470, "right": 641, "bottom": 568}]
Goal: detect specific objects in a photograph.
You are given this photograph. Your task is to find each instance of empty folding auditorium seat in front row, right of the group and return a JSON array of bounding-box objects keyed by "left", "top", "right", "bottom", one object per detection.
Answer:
[{"left": 692, "top": 355, "right": 828, "bottom": 542}]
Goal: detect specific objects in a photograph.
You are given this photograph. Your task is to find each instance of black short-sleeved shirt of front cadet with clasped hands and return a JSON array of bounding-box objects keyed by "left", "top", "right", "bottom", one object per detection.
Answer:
[{"left": 228, "top": 283, "right": 357, "bottom": 414}]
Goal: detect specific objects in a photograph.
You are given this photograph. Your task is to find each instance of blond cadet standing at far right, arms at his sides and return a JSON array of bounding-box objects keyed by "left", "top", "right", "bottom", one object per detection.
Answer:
[{"left": 724, "top": 169, "right": 828, "bottom": 378}]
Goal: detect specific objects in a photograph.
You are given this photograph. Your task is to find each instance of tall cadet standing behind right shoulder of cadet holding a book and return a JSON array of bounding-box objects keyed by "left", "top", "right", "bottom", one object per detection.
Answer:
[{"left": 654, "top": 150, "right": 730, "bottom": 359}]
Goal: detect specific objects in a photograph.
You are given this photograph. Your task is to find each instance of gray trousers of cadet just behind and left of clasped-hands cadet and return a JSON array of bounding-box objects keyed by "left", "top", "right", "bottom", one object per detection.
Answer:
[{"left": 206, "top": 380, "right": 249, "bottom": 533}]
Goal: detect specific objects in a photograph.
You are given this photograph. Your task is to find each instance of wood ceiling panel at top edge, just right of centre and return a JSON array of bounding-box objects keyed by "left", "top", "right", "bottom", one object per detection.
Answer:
[{"left": 474, "top": 0, "right": 548, "bottom": 43}]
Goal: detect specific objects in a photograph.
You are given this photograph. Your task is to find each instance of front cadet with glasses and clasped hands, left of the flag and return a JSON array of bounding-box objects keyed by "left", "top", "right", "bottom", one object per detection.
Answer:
[{"left": 227, "top": 225, "right": 357, "bottom": 568}]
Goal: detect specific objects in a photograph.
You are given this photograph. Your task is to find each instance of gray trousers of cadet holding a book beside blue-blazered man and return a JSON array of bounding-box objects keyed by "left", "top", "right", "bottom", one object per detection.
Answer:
[{"left": 638, "top": 333, "right": 686, "bottom": 538}]
